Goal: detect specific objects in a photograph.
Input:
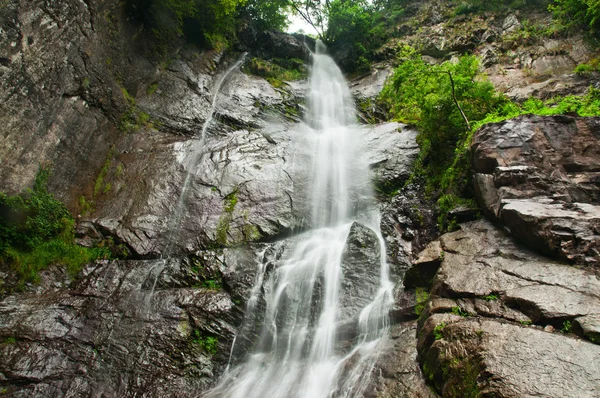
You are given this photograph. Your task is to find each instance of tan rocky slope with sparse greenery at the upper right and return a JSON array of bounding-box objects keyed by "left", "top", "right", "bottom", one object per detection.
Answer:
[{"left": 376, "top": 0, "right": 598, "bottom": 102}]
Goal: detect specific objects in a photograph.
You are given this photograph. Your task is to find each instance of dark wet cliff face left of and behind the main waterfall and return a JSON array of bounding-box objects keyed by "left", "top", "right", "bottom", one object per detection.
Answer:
[{"left": 0, "top": 0, "right": 426, "bottom": 397}]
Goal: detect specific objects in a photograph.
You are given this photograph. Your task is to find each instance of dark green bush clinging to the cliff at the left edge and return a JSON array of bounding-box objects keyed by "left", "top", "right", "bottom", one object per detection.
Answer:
[{"left": 0, "top": 167, "right": 110, "bottom": 283}]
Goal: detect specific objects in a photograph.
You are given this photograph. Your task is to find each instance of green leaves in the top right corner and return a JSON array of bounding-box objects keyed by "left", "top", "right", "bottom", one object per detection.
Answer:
[{"left": 548, "top": 0, "right": 600, "bottom": 35}]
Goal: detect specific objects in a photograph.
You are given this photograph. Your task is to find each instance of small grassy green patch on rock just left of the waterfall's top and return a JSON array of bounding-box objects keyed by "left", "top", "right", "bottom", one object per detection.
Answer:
[{"left": 244, "top": 58, "right": 308, "bottom": 88}]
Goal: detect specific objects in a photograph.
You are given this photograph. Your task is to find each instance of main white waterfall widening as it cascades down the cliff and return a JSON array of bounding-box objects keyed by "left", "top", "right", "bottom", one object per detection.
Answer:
[{"left": 206, "top": 43, "right": 393, "bottom": 398}]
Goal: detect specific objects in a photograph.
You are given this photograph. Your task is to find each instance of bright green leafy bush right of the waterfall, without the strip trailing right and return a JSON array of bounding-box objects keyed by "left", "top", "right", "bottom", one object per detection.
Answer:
[{"left": 381, "top": 46, "right": 508, "bottom": 197}]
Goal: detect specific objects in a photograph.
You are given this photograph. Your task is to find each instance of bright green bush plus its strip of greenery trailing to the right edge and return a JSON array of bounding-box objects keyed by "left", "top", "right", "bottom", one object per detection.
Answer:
[{"left": 380, "top": 46, "right": 600, "bottom": 229}]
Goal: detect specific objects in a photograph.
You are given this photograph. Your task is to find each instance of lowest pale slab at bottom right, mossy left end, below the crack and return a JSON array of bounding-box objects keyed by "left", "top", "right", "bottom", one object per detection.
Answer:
[{"left": 419, "top": 314, "right": 600, "bottom": 397}]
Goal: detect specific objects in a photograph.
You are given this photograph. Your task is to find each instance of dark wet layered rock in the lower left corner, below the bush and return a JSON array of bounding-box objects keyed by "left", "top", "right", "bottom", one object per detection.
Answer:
[{"left": 0, "top": 253, "right": 242, "bottom": 397}]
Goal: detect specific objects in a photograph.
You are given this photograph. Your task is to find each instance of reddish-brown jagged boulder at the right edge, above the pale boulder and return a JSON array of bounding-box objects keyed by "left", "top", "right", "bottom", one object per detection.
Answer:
[{"left": 472, "top": 116, "right": 600, "bottom": 267}]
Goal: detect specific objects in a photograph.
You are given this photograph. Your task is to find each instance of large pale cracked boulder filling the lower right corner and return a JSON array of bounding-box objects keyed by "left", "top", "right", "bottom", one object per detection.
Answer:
[{"left": 418, "top": 221, "right": 600, "bottom": 397}]
